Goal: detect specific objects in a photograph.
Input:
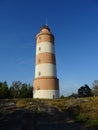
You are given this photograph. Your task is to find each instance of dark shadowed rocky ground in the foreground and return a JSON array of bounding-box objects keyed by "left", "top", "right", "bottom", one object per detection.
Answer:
[{"left": 0, "top": 103, "right": 83, "bottom": 130}]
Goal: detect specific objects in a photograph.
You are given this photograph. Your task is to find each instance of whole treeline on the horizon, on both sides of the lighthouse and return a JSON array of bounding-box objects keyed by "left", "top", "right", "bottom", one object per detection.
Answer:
[{"left": 0, "top": 80, "right": 98, "bottom": 99}]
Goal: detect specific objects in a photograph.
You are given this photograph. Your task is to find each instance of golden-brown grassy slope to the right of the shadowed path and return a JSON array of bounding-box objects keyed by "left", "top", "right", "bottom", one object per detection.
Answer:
[{"left": 38, "top": 97, "right": 98, "bottom": 130}]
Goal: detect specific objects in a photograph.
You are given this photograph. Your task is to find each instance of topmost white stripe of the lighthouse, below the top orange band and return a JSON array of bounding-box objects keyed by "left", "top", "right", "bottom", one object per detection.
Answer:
[{"left": 36, "top": 42, "right": 55, "bottom": 55}]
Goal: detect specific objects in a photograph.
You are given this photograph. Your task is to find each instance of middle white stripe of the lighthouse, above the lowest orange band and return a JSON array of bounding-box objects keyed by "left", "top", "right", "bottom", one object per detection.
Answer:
[{"left": 35, "top": 64, "right": 57, "bottom": 78}]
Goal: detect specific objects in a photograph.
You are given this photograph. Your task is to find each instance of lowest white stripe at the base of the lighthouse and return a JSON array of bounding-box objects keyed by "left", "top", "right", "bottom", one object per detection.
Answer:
[{"left": 33, "top": 90, "right": 59, "bottom": 99}]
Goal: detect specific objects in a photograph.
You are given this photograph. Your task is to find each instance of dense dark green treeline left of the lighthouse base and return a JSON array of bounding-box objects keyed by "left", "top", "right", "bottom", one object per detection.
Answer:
[{"left": 0, "top": 81, "right": 33, "bottom": 99}]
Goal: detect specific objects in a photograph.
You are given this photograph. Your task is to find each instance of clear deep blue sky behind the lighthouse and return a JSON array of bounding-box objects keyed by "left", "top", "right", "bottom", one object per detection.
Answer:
[{"left": 0, "top": 0, "right": 98, "bottom": 96}]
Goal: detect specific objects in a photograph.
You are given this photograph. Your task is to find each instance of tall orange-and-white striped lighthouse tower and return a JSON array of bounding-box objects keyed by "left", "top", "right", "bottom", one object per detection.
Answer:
[{"left": 33, "top": 25, "right": 59, "bottom": 99}]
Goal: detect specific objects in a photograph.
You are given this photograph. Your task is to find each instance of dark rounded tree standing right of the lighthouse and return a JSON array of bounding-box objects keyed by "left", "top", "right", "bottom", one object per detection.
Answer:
[{"left": 78, "top": 84, "right": 92, "bottom": 97}]
